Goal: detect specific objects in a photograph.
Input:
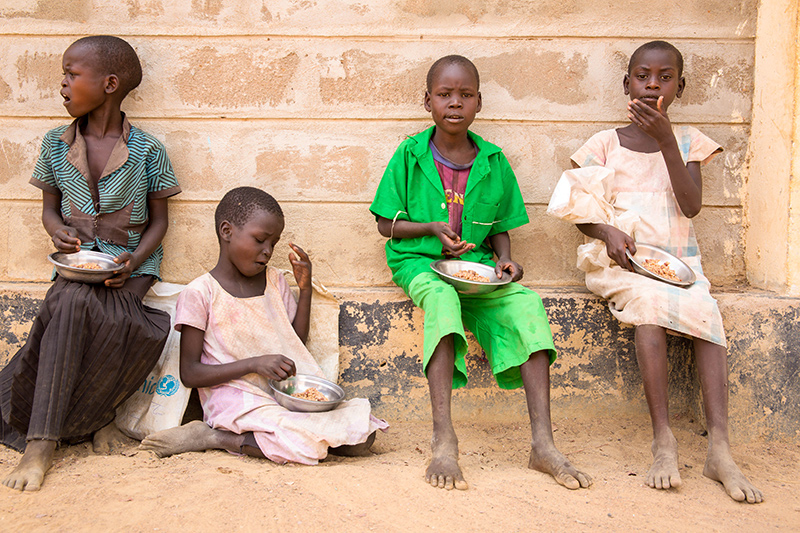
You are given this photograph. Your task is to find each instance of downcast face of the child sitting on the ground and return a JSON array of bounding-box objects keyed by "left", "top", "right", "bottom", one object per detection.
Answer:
[{"left": 220, "top": 210, "right": 284, "bottom": 277}]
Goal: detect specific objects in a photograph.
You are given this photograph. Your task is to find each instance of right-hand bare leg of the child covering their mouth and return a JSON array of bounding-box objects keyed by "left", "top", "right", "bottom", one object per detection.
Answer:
[{"left": 694, "top": 339, "right": 763, "bottom": 503}]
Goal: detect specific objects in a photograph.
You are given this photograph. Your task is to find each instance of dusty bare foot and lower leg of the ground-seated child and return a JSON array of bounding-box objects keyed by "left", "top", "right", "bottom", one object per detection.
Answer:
[{"left": 139, "top": 420, "right": 264, "bottom": 458}]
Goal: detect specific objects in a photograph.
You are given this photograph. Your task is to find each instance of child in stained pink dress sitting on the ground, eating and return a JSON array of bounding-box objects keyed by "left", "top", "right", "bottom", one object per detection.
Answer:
[{"left": 142, "top": 187, "right": 388, "bottom": 464}]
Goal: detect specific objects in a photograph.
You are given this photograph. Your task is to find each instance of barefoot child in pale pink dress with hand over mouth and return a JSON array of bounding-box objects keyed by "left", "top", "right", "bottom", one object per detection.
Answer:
[{"left": 548, "top": 41, "right": 762, "bottom": 503}]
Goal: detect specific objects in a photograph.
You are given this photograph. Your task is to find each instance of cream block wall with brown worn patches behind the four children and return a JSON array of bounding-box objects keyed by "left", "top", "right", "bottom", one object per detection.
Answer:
[{"left": 0, "top": 0, "right": 756, "bottom": 287}]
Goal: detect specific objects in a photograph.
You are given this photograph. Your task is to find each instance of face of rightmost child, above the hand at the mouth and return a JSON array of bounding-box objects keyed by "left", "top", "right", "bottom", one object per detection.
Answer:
[{"left": 623, "top": 49, "right": 686, "bottom": 111}]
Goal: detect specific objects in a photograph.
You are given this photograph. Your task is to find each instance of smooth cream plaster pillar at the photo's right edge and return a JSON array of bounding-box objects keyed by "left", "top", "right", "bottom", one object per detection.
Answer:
[{"left": 745, "top": 0, "right": 800, "bottom": 295}]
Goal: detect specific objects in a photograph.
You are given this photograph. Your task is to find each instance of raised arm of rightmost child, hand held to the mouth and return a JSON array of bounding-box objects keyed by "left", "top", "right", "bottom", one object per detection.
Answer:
[{"left": 628, "top": 96, "right": 703, "bottom": 218}]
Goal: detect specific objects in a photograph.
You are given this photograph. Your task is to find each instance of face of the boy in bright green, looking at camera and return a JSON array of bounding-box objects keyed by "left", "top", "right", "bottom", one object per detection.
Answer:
[{"left": 425, "top": 63, "right": 481, "bottom": 135}]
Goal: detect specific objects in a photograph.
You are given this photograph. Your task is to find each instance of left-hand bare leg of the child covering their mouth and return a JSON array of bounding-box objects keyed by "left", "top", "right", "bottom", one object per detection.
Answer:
[{"left": 636, "top": 325, "right": 682, "bottom": 489}]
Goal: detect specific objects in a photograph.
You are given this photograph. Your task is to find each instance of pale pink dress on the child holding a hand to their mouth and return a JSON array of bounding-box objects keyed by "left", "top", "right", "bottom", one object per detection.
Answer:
[{"left": 548, "top": 126, "right": 726, "bottom": 346}]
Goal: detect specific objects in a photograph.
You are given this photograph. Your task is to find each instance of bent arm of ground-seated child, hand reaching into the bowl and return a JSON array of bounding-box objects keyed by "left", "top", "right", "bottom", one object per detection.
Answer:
[{"left": 181, "top": 324, "right": 295, "bottom": 388}]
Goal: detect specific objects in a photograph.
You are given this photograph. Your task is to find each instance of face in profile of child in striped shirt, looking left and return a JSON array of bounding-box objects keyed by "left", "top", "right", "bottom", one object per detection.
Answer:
[{"left": 61, "top": 44, "right": 107, "bottom": 117}]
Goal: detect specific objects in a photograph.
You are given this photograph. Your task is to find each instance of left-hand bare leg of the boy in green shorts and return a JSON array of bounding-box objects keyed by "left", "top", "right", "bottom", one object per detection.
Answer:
[{"left": 425, "top": 335, "right": 469, "bottom": 490}]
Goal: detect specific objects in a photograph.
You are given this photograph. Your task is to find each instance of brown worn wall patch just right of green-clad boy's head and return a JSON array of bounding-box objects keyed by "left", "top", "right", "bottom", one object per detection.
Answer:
[{"left": 474, "top": 50, "right": 589, "bottom": 105}]
